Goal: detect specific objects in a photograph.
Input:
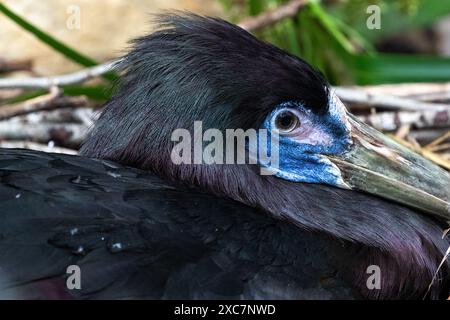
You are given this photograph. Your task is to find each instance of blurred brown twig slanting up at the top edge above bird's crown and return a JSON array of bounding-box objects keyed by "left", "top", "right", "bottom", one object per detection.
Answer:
[{"left": 239, "top": 0, "right": 308, "bottom": 31}]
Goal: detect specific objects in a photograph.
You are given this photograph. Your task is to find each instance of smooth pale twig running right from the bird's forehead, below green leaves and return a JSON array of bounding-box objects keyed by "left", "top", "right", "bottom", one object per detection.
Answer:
[{"left": 335, "top": 87, "right": 450, "bottom": 112}]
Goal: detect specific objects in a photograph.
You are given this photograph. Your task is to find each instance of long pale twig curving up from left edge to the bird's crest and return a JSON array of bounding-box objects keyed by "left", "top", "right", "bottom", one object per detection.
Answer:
[{"left": 0, "top": 59, "right": 120, "bottom": 89}]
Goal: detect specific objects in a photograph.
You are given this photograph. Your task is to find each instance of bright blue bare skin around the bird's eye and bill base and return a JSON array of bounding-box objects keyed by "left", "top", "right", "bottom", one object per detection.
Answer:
[{"left": 258, "top": 99, "right": 351, "bottom": 187}]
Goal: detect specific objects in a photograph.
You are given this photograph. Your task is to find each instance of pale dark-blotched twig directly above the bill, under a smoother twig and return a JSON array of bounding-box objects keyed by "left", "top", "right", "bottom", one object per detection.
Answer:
[{"left": 358, "top": 110, "right": 450, "bottom": 131}]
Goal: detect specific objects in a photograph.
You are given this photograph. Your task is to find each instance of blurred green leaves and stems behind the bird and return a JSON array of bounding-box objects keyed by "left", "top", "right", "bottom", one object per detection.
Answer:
[{"left": 0, "top": 0, "right": 450, "bottom": 95}]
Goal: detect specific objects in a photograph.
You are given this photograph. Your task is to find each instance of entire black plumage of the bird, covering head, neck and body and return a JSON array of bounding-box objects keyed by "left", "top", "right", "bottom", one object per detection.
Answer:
[{"left": 0, "top": 15, "right": 449, "bottom": 299}]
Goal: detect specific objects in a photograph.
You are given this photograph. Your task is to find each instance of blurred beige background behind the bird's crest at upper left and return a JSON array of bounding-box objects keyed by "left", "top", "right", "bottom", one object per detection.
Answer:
[{"left": 0, "top": 0, "right": 222, "bottom": 75}]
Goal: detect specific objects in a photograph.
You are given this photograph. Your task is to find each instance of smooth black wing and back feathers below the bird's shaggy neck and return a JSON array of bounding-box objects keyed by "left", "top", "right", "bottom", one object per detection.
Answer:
[{"left": 0, "top": 150, "right": 357, "bottom": 299}]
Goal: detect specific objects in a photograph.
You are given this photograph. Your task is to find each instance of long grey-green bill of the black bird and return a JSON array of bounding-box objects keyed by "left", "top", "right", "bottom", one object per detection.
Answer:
[{"left": 329, "top": 114, "right": 450, "bottom": 221}]
